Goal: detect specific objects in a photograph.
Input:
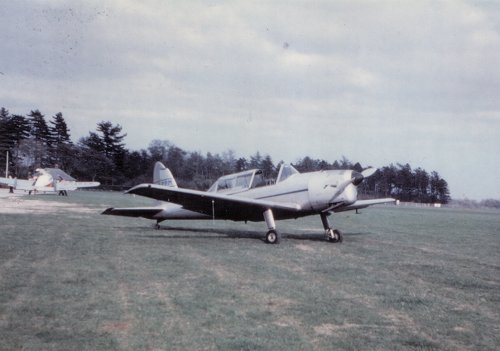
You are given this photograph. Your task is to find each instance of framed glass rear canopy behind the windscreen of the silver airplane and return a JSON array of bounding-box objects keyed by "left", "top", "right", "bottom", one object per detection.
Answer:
[{"left": 208, "top": 169, "right": 266, "bottom": 193}]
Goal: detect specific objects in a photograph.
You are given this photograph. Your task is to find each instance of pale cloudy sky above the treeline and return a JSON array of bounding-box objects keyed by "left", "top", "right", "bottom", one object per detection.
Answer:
[{"left": 0, "top": 0, "right": 500, "bottom": 200}]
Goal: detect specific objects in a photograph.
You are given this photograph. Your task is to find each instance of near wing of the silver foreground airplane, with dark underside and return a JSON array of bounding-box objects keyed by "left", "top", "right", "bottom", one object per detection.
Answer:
[{"left": 127, "top": 184, "right": 300, "bottom": 221}]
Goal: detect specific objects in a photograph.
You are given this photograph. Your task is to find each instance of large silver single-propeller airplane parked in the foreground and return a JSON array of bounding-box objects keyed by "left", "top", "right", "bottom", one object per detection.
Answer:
[{"left": 102, "top": 162, "right": 395, "bottom": 244}]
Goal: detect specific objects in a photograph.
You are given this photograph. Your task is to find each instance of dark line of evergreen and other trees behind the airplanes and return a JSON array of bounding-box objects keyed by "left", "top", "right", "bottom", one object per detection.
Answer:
[{"left": 0, "top": 108, "right": 450, "bottom": 203}]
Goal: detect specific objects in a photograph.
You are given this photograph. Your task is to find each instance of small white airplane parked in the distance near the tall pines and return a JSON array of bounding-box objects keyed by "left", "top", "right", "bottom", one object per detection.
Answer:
[{"left": 0, "top": 168, "right": 100, "bottom": 196}]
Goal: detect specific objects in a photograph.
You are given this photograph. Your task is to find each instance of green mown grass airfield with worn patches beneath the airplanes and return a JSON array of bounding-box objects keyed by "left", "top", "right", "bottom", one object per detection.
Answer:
[{"left": 0, "top": 190, "right": 500, "bottom": 350}]
